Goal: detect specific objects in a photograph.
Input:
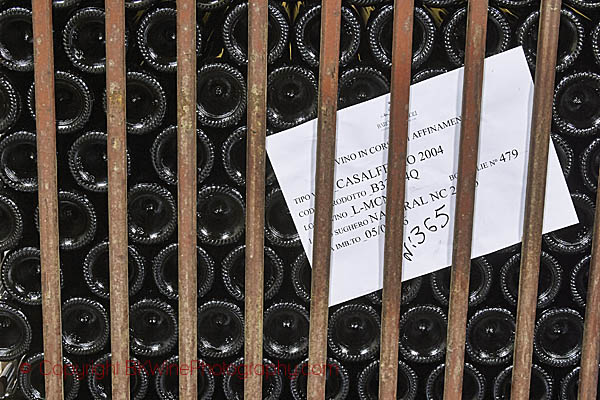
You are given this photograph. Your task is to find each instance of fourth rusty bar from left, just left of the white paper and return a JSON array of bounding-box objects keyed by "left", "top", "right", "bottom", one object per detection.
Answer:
[{"left": 244, "top": 0, "right": 269, "bottom": 400}]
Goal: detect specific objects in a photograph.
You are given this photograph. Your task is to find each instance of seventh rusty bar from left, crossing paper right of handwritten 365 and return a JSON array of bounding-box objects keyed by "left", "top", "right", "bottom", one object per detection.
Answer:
[{"left": 444, "top": 0, "right": 488, "bottom": 400}]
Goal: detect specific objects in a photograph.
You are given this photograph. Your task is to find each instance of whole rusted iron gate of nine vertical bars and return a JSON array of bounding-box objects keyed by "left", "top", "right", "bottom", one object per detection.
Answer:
[{"left": 27, "top": 0, "right": 600, "bottom": 400}]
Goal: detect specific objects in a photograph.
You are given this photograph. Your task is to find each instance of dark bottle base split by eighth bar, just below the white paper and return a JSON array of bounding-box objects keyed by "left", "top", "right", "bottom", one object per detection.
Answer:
[{"left": 500, "top": 251, "right": 562, "bottom": 308}]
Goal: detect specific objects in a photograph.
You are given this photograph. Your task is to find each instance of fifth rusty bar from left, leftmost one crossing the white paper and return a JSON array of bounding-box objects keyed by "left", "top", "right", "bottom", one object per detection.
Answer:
[{"left": 307, "top": 0, "right": 341, "bottom": 400}]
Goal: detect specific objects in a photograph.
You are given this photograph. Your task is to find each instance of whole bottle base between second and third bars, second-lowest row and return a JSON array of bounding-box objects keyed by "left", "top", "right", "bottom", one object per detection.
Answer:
[{"left": 129, "top": 299, "right": 178, "bottom": 357}]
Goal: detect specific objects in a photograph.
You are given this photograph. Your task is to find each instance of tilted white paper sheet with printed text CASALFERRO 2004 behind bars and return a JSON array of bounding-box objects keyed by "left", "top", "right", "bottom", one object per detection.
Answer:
[{"left": 267, "top": 47, "right": 578, "bottom": 305}]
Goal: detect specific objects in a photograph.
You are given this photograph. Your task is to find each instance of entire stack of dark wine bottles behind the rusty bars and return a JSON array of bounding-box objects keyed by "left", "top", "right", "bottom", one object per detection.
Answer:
[{"left": 0, "top": 0, "right": 600, "bottom": 400}]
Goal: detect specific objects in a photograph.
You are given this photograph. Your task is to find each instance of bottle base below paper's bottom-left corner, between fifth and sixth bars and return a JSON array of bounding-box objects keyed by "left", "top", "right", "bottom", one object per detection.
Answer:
[{"left": 327, "top": 303, "right": 381, "bottom": 362}]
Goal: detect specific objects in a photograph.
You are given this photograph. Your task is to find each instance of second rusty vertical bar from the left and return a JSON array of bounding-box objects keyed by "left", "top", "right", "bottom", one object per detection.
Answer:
[{"left": 105, "top": 0, "right": 129, "bottom": 400}]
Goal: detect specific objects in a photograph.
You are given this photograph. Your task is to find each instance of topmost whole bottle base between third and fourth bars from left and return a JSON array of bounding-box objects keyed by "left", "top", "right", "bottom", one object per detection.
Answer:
[{"left": 196, "top": 63, "right": 246, "bottom": 128}]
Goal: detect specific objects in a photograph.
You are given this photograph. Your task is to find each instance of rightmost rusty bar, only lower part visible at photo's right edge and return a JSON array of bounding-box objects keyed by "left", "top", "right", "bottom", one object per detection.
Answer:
[{"left": 578, "top": 173, "right": 600, "bottom": 400}]
